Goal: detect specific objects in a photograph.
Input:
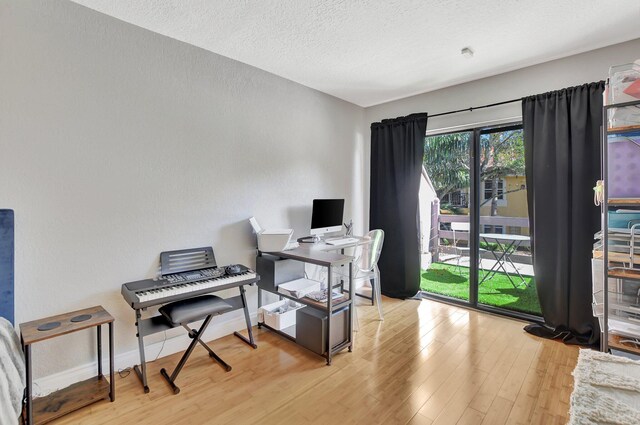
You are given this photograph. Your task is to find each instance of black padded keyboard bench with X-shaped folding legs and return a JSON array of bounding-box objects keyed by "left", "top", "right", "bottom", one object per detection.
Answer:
[{"left": 158, "top": 295, "right": 233, "bottom": 394}]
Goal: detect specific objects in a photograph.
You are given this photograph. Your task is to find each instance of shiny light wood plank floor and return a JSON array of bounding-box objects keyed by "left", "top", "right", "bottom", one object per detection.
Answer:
[{"left": 56, "top": 298, "right": 578, "bottom": 425}]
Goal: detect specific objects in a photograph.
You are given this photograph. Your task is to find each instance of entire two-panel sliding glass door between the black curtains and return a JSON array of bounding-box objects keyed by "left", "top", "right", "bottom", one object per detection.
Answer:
[{"left": 420, "top": 125, "right": 541, "bottom": 316}]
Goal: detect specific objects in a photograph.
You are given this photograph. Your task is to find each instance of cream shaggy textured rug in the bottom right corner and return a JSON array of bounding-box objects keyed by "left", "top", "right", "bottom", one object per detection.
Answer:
[{"left": 569, "top": 349, "right": 640, "bottom": 425}]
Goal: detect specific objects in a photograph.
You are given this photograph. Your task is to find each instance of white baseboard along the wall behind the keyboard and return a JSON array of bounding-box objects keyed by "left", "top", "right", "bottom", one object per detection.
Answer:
[{"left": 33, "top": 313, "right": 257, "bottom": 397}]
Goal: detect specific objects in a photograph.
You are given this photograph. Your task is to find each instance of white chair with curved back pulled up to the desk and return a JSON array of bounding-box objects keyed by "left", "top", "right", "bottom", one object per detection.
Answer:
[{"left": 336, "top": 229, "right": 384, "bottom": 324}]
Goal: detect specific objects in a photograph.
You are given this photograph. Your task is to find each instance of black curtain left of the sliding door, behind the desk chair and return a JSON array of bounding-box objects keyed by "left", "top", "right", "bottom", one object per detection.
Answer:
[{"left": 369, "top": 113, "right": 427, "bottom": 298}]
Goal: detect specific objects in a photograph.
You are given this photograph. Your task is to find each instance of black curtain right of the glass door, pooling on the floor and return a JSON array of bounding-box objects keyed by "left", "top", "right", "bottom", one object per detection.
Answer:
[{"left": 522, "top": 82, "right": 604, "bottom": 345}]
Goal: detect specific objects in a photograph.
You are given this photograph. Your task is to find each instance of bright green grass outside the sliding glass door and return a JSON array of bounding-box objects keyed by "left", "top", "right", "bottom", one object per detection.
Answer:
[{"left": 420, "top": 263, "right": 542, "bottom": 316}]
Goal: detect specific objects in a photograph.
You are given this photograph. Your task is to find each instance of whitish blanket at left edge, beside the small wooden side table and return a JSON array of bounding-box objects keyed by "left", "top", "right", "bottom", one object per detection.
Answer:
[{"left": 0, "top": 317, "right": 26, "bottom": 425}]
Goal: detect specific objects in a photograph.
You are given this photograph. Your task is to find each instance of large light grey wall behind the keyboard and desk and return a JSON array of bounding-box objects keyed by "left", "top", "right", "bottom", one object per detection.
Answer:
[{"left": 0, "top": 0, "right": 368, "bottom": 384}]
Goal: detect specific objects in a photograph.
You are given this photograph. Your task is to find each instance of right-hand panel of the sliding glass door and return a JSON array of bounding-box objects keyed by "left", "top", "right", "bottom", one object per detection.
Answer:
[{"left": 477, "top": 125, "right": 541, "bottom": 316}]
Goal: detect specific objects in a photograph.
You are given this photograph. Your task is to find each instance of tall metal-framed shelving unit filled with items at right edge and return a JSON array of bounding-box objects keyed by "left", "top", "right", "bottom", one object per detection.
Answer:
[{"left": 592, "top": 73, "right": 640, "bottom": 353}]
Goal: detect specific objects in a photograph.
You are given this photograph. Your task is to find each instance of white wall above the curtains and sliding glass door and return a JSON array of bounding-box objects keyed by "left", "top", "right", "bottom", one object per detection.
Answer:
[{"left": 364, "top": 39, "right": 640, "bottom": 232}]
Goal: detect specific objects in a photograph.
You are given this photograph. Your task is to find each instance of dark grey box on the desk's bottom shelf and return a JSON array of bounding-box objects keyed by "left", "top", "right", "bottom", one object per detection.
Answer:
[{"left": 296, "top": 307, "right": 349, "bottom": 355}]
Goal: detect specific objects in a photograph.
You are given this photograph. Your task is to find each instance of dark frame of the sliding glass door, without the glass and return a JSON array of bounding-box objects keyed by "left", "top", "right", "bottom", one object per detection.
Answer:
[{"left": 421, "top": 122, "right": 544, "bottom": 323}]
